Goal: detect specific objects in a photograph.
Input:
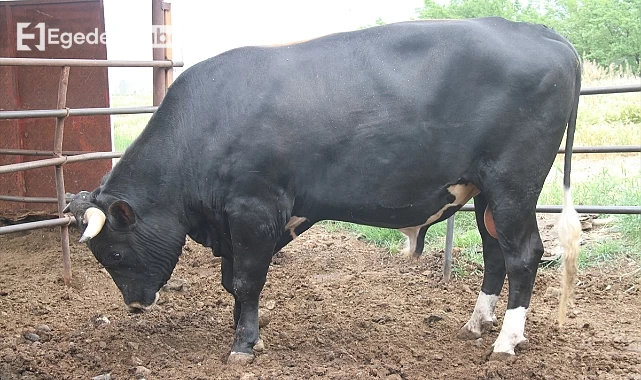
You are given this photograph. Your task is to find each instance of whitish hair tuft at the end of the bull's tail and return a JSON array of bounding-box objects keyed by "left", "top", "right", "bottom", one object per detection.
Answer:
[{"left": 558, "top": 187, "right": 581, "bottom": 326}]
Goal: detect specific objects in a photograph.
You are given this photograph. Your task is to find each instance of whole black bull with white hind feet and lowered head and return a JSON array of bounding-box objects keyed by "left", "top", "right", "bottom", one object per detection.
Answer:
[{"left": 69, "top": 18, "right": 581, "bottom": 362}]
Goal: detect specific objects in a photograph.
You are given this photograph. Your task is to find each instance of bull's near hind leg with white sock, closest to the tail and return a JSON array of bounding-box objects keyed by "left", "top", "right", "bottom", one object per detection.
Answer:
[{"left": 492, "top": 205, "right": 543, "bottom": 359}]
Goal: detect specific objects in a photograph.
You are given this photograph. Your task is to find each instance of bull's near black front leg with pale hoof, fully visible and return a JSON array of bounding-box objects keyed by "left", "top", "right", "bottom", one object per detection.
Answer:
[{"left": 227, "top": 212, "right": 277, "bottom": 364}]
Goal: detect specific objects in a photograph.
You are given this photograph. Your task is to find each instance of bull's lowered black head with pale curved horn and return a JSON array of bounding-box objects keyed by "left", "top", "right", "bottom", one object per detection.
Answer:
[{"left": 65, "top": 191, "right": 184, "bottom": 311}]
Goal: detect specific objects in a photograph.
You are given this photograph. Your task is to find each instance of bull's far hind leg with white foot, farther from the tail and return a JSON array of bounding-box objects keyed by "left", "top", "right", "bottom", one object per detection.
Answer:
[{"left": 458, "top": 194, "right": 505, "bottom": 339}]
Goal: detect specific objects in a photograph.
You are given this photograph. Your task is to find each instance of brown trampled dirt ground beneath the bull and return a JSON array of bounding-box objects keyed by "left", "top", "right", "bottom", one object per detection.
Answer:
[{"left": 0, "top": 217, "right": 641, "bottom": 380}]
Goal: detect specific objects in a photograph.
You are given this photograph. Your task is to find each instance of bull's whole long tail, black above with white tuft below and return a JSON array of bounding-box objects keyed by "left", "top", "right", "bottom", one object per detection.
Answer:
[{"left": 558, "top": 60, "right": 581, "bottom": 325}]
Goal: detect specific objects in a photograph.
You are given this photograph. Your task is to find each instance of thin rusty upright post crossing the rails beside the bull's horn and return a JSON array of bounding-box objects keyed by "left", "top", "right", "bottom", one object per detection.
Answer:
[{"left": 53, "top": 66, "right": 71, "bottom": 285}]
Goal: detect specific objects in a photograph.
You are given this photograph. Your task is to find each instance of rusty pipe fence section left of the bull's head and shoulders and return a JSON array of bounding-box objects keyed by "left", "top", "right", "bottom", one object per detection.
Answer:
[{"left": 0, "top": 58, "right": 183, "bottom": 283}]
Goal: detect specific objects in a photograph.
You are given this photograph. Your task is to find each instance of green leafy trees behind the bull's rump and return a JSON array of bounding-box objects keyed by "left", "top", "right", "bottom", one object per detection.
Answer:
[{"left": 418, "top": 0, "right": 641, "bottom": 73}]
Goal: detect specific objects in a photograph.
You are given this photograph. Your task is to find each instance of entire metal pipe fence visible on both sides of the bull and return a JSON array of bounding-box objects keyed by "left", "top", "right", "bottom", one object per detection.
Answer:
[{"left": 0, "top": 63, "right": 641, "bottom": 282}]
